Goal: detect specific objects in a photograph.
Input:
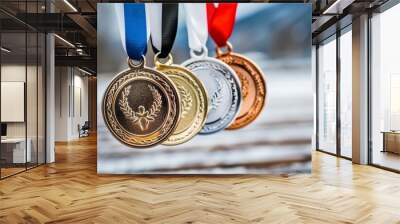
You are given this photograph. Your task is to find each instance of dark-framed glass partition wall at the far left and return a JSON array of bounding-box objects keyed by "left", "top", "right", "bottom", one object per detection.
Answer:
[{"left": 0, "top": 1, "right": 46, "bottom": 179}]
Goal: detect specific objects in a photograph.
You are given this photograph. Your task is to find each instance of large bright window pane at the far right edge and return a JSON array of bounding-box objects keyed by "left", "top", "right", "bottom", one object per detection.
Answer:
[{"left": 371, "top": 5, "right": 400, "bottom": 170}]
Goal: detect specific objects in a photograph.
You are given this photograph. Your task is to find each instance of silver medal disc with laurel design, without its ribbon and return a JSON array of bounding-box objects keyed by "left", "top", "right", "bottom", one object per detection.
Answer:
[{"left": 182, "top": 52, "right": 242, "bottom": 134}]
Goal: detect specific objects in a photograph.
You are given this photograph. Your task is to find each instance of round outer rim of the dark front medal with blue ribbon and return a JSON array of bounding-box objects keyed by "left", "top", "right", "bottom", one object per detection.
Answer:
[{"left": 101, "top": 66, "right": 181, "bottom": 148}]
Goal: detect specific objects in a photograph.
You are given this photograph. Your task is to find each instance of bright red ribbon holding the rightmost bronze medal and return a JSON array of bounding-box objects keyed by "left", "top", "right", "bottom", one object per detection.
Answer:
[{"left": 207, "top": 3, "right": 237, "bottom": 47}]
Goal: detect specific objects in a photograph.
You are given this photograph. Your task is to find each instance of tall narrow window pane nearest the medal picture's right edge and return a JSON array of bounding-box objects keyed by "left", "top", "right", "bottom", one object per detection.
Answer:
[{"left": 318, "top": 39, "right": 336, "bottom": 153}]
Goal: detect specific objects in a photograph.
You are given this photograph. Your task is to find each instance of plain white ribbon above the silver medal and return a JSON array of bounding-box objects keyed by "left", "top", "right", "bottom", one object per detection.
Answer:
[{"left": 183, "top": 3, "right": 208, "bottom": 54}]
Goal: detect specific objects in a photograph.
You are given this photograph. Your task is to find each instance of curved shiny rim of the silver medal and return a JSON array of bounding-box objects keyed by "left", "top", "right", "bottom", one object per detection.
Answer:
[{"left": 181, "top": 56, "right": 242, "bottom": 135}]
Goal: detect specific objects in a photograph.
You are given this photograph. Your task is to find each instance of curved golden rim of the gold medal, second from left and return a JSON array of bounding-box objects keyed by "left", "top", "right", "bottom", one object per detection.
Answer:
[{"left": 156, "top": 64, "right": 208, "bottom": 146}]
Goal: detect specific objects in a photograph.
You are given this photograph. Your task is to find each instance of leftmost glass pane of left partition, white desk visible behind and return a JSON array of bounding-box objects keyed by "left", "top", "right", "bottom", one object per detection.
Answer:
[{"left": 0, "top": 32, "right": 27, "bottom": 177}]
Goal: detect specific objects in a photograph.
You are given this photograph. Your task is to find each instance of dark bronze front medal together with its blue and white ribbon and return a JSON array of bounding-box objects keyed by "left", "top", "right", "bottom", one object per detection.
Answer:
[{"left": 102, "top": 3, "right": 180, "bottom": 147}]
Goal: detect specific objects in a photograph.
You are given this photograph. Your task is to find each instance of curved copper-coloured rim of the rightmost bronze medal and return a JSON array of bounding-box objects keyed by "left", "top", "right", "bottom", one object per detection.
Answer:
[{"left": 216, "top": 52, "right": 268, "bottom": 130}]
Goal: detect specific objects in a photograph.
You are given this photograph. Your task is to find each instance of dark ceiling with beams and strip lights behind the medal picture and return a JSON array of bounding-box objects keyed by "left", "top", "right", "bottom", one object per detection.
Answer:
[{"left": 0, "top": 0, "right": 394, "bottom": 73}]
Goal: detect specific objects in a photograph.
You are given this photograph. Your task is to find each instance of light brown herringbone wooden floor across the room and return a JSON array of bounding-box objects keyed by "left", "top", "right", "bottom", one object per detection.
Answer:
[{"left": 0, "top": 137, "right": 400, "bottom": 224}]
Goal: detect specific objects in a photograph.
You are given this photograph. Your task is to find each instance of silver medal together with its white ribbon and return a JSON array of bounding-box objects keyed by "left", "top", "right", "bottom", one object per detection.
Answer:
[{"left": 182, "top": 3, "right": 242, "bottom": 134}]
